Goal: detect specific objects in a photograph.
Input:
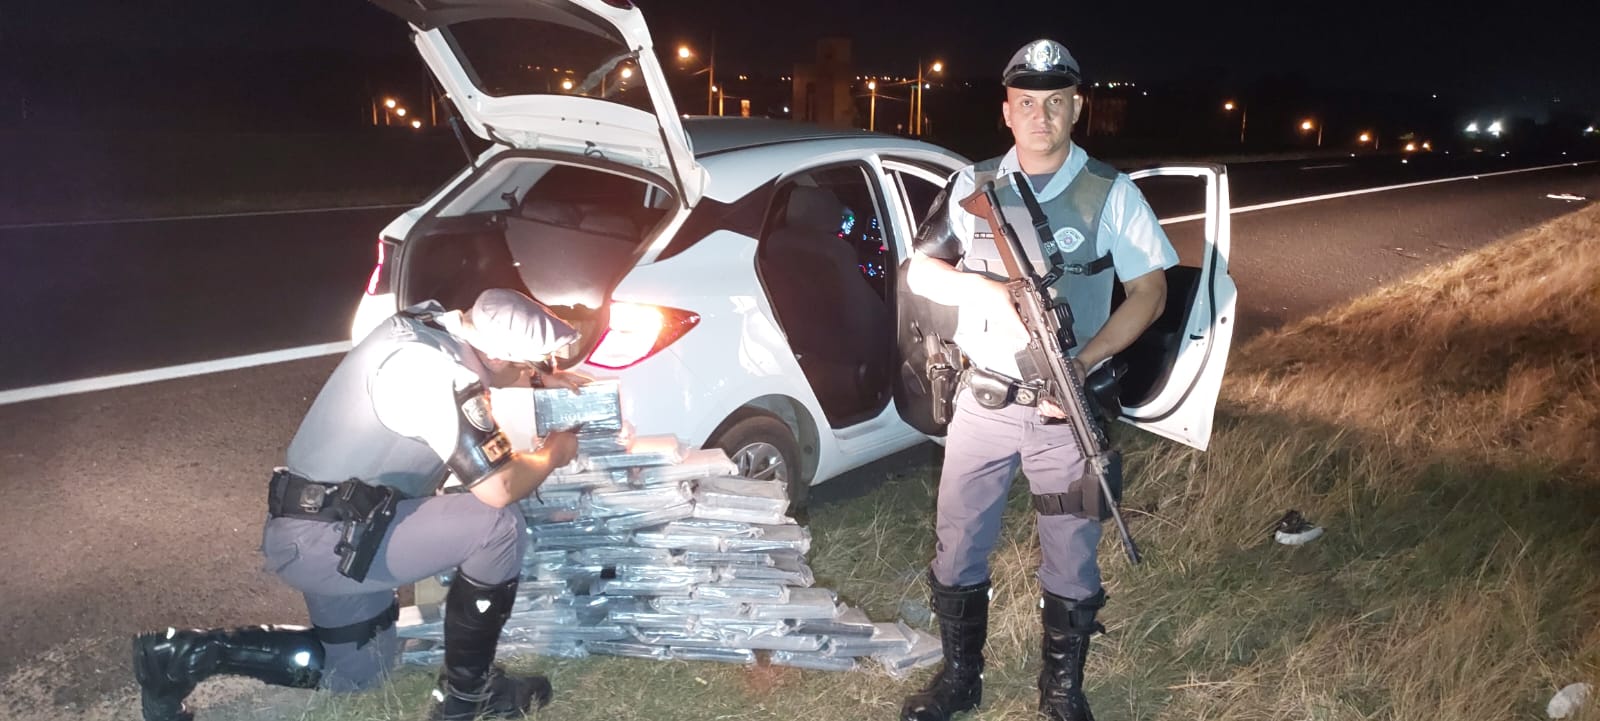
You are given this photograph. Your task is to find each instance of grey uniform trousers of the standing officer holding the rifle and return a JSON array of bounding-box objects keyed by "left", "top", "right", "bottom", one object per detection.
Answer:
[{"left": 933, "top": 387, "right": 1101, "bottom": 600}]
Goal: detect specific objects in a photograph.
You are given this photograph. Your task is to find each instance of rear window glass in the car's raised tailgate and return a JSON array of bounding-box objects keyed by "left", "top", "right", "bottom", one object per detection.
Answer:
[{"left": 446, "top": 10, "right": 654, "bottom": 112}]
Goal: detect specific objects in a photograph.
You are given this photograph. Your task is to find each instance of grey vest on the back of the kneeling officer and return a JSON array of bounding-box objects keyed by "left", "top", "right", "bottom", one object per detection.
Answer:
[{"left": 288, "top": 304, "right": 488, "bottom": 497}]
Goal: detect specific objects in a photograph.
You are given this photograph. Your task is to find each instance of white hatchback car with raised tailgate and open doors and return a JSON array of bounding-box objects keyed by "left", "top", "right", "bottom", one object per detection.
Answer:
[{"left": 360, "top": 0, "right": 1234, "bottom": 511}]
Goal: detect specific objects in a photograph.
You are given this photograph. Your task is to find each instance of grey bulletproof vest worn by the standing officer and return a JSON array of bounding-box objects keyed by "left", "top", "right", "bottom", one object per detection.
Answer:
[{"left": 962, "top": 158, "right": 1117, "bottom": 355}]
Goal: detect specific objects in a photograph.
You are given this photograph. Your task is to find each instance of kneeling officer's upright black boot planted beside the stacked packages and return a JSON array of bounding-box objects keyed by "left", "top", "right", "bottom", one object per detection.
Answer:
[{"left": 430, "top": 569, "right": 550, "bottom": 721}]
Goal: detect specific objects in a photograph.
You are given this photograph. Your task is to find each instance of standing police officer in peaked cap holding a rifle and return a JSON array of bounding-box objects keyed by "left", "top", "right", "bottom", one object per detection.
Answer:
[{"left": 901, "top": 40, "right": 1178, "bottom": 721}]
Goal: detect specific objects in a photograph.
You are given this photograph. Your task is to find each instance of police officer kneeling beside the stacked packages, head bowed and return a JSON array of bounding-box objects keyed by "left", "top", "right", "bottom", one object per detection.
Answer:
[{"left": 133, "top": 289, "right": 587, "bottom": 721}]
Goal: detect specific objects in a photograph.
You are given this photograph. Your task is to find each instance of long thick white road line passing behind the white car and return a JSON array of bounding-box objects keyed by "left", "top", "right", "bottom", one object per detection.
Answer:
[{"left": 0, "top": 160, "right": 1600, "bottom": 406}]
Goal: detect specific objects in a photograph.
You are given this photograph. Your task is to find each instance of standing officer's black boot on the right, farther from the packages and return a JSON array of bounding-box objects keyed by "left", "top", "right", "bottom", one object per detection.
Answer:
[{"left": 1038, "top": 590, "right": 1106, "bottom": 721}]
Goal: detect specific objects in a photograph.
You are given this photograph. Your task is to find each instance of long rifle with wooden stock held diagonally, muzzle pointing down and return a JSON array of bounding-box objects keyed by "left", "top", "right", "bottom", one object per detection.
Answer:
[{"left": 960, "top": 173, "right": 1139, "bottom": 563}]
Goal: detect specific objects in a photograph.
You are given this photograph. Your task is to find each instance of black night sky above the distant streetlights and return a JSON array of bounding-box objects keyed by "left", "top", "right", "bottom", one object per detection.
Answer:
[{"left": 0, "top": 0, "right": 1600, "bottom": 118}]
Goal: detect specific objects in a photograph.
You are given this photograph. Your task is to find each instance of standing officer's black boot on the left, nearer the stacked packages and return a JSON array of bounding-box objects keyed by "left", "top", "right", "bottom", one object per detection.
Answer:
[{"left": 901, "top": 574, "right": 989, "bottom": 721}]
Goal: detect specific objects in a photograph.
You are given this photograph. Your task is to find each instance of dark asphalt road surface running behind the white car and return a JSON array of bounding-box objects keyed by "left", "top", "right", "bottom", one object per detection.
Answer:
[{"left": 0, "top": 152, "right": 1600, "bottom": 718}]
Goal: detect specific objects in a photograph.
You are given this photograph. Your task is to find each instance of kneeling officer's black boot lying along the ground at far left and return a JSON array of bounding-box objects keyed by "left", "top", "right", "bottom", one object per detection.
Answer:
[{"left": 133, "top": 625, "right": 323, "bottom": 721}]
